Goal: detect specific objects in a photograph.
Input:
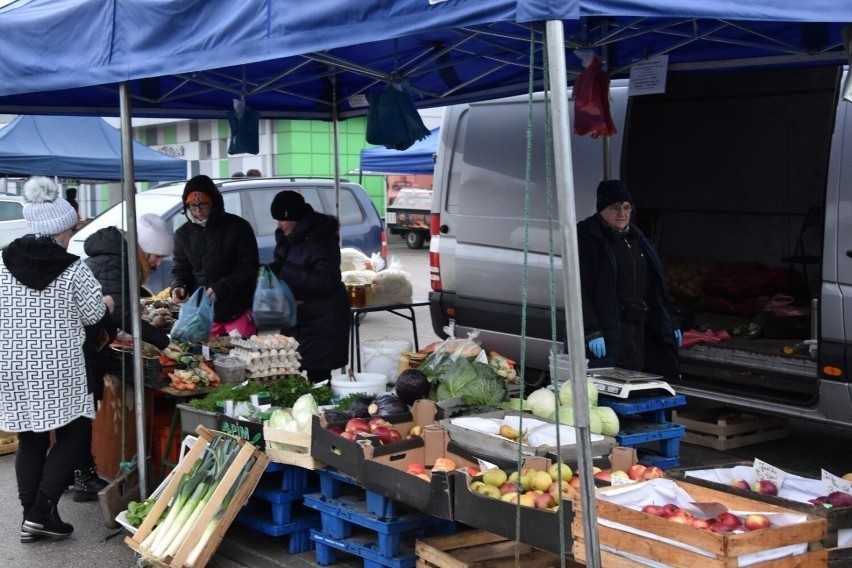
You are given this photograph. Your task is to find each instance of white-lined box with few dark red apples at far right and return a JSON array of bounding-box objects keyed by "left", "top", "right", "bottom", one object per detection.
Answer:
[{"left": 666, "top": 462, "right": 852, "bottom": 566}]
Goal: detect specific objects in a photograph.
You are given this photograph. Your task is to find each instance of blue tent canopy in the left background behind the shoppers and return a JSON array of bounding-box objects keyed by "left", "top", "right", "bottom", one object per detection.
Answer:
[{"left": 0, "top": 116, "right": 186, "bottom": 181}]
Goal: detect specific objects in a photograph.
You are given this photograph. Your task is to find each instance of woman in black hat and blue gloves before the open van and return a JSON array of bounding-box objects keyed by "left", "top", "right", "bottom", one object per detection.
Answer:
[{"left": 577, "top": 180, "right": 681, "bottom": 377}]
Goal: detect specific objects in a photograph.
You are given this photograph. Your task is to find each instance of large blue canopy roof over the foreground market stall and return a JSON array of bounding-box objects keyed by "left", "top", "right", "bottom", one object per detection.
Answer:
[{"left": 0, "top": 0, "right": 852, "bottom": 119}]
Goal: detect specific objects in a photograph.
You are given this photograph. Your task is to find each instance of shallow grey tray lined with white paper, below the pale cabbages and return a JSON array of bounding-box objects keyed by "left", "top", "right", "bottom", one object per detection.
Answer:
[{"left": 440, "top": 410, "right": 617, "bottom": 462}]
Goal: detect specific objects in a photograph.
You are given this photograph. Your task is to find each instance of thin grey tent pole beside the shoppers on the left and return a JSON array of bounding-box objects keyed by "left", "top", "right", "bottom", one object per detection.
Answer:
[{"left": 119, "top": 81, "right": 148, "bottom": 501}]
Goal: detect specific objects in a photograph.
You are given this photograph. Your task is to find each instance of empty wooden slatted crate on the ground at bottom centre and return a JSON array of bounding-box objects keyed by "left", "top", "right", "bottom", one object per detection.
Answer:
[{"left": 414, "top": 530, "right": 582, "bottom": 568}]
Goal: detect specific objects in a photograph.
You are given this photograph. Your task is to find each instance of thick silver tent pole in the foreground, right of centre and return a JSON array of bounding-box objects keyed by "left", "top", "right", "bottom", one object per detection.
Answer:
[{"left": 545, "top": 20, "right": 601, "bottom": 568}]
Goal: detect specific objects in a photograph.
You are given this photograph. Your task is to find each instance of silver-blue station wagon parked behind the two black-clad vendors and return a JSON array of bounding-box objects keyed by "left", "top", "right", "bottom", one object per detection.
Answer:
[{"left": 68, "top": 178, "right": 387, "bottom": 292}]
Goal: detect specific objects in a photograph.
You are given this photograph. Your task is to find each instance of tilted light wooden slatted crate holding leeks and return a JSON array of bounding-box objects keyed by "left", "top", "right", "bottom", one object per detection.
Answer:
[{"left": 124, "top": 426, "right": 269, "bottom": 568}]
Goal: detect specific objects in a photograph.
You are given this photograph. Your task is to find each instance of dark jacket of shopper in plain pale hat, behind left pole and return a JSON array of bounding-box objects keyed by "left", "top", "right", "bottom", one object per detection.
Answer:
[{"left": 83, "top": 227, "right": 169, "bottom": 350}]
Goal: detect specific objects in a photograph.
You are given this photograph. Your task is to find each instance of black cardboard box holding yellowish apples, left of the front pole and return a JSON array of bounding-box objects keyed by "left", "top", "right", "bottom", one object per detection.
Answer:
[{"left": 453, "top": 456, "right": 574, "bottom": 554}]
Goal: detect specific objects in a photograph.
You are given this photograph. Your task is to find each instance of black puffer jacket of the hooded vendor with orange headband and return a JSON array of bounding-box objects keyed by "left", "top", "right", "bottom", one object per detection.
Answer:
[{"left": 171, "top": 192, "right": 260, "bottom": 323}]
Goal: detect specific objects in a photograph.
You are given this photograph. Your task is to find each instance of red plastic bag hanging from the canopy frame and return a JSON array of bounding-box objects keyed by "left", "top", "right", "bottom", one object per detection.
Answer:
[{"left": 574, "top": 55, "right": 618, "bottom": 138}]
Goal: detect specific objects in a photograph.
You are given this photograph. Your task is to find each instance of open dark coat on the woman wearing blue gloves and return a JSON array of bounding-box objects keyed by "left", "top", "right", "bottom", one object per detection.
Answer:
[{"left": 577, "top": 215, "right": 680, "bottom": 377}]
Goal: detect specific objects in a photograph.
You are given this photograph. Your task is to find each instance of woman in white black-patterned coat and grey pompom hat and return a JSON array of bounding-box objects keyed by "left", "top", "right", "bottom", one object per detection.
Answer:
[{"left": 0, "top": 177, "right": 110, "bottom": 542}]
